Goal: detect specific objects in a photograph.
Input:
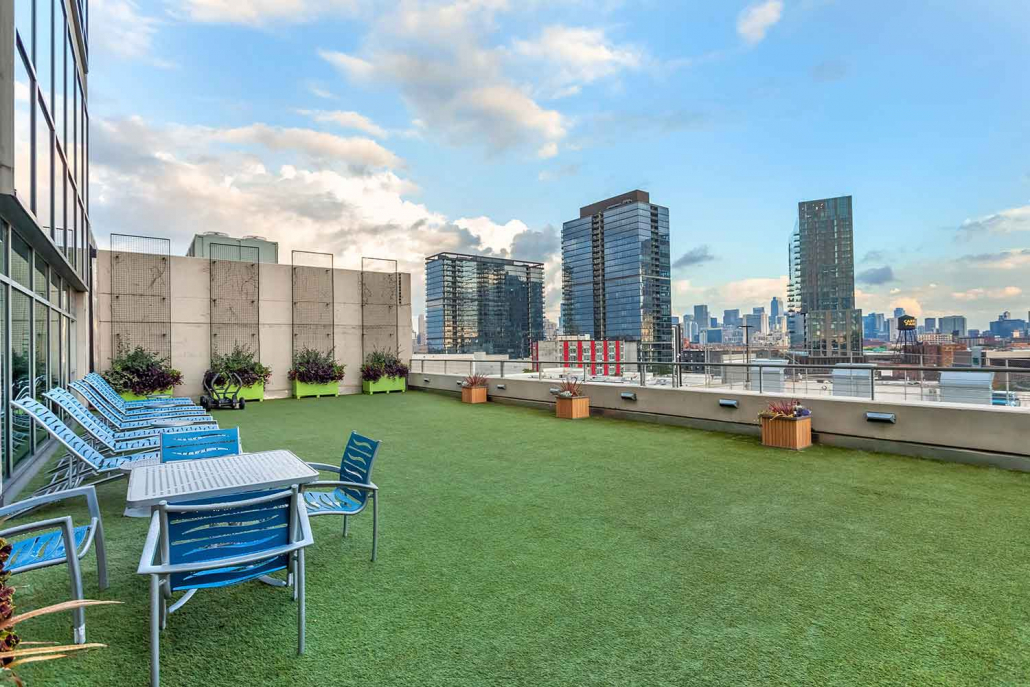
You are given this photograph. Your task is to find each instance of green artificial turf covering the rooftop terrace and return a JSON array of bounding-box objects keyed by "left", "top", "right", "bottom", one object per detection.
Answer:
[{"left": 13, "top": 392, "right": 1030, "bottom": 687}]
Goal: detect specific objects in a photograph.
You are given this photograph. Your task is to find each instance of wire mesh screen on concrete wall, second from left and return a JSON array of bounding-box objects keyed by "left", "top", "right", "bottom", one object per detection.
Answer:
[{"left": 208, "top": 243, "right": 261, "bottom": 359}]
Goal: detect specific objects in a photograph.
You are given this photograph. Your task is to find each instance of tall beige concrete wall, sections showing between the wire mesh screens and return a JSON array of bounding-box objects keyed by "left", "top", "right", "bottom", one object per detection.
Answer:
[{"left": 96, "top": 250, "right": 411, "bottom": 399}]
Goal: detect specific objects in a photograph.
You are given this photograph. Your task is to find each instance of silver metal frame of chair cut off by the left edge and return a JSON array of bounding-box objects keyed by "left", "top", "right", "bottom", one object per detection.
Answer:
[{"left": 0, "top": 486, "right": 108, "bottom": 644}]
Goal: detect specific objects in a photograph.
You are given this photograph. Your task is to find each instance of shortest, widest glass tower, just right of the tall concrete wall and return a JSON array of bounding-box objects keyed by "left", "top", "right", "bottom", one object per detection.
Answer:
[{"left": 425, "top": 252, "right": 544, "bottom": 359}]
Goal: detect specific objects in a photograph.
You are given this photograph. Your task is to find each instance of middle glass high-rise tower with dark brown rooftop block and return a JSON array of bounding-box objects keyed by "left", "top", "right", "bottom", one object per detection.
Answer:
[{"left": 561, "top": 191, "right": 675, "bottom": 362}]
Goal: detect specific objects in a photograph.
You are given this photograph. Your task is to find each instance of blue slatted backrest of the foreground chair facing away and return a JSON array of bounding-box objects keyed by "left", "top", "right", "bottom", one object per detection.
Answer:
[{"left": 166, "top": 492, "right": 296, "bottom": 589}]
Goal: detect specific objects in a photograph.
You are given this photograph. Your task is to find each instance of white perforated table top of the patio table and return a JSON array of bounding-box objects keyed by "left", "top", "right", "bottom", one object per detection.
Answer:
[{"left": 126, "top": 450, "right": 318, "bottom": 509}]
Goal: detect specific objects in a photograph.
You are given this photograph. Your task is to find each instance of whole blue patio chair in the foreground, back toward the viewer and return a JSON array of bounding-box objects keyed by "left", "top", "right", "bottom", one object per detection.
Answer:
[{"left": 137, "top": 487, "right": 314, "bottom": 687}]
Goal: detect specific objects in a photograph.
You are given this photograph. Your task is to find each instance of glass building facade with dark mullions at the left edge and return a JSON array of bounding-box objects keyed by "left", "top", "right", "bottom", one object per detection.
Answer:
[{"left": 0, "top": 0, "right": 95, "bottom": 496}]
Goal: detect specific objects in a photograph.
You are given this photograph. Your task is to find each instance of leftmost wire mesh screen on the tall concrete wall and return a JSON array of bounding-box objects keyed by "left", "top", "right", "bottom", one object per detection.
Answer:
[{"left": 111, "top": 234, "right": 172, "bottom": 358}]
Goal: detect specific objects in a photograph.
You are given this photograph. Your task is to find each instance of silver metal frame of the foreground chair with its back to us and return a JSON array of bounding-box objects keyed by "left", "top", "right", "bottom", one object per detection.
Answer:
[{"left": 136, "top": 486, "right": 314, "bottom": 687}]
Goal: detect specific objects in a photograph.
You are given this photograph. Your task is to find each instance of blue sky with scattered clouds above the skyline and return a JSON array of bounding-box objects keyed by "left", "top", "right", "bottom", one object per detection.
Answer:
[{"left": 90, "top": 0, "right": 1030, "bottom": 328}]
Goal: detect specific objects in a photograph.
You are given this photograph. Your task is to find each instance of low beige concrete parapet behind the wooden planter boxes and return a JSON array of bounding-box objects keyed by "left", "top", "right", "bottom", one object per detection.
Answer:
[{"left": 408, "top": 372, "right": 1030, "bottom": 472}]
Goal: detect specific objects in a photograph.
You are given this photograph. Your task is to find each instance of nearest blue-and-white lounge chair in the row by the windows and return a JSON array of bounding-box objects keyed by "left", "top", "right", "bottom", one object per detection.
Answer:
[{"left": 11, "top": 399, "right": 161, "bottom": 493}]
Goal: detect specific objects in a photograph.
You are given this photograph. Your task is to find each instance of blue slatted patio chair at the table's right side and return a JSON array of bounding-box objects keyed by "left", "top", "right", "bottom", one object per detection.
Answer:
[{"left": 301, "top": 432, "right": 382, "bottom": 561}]
